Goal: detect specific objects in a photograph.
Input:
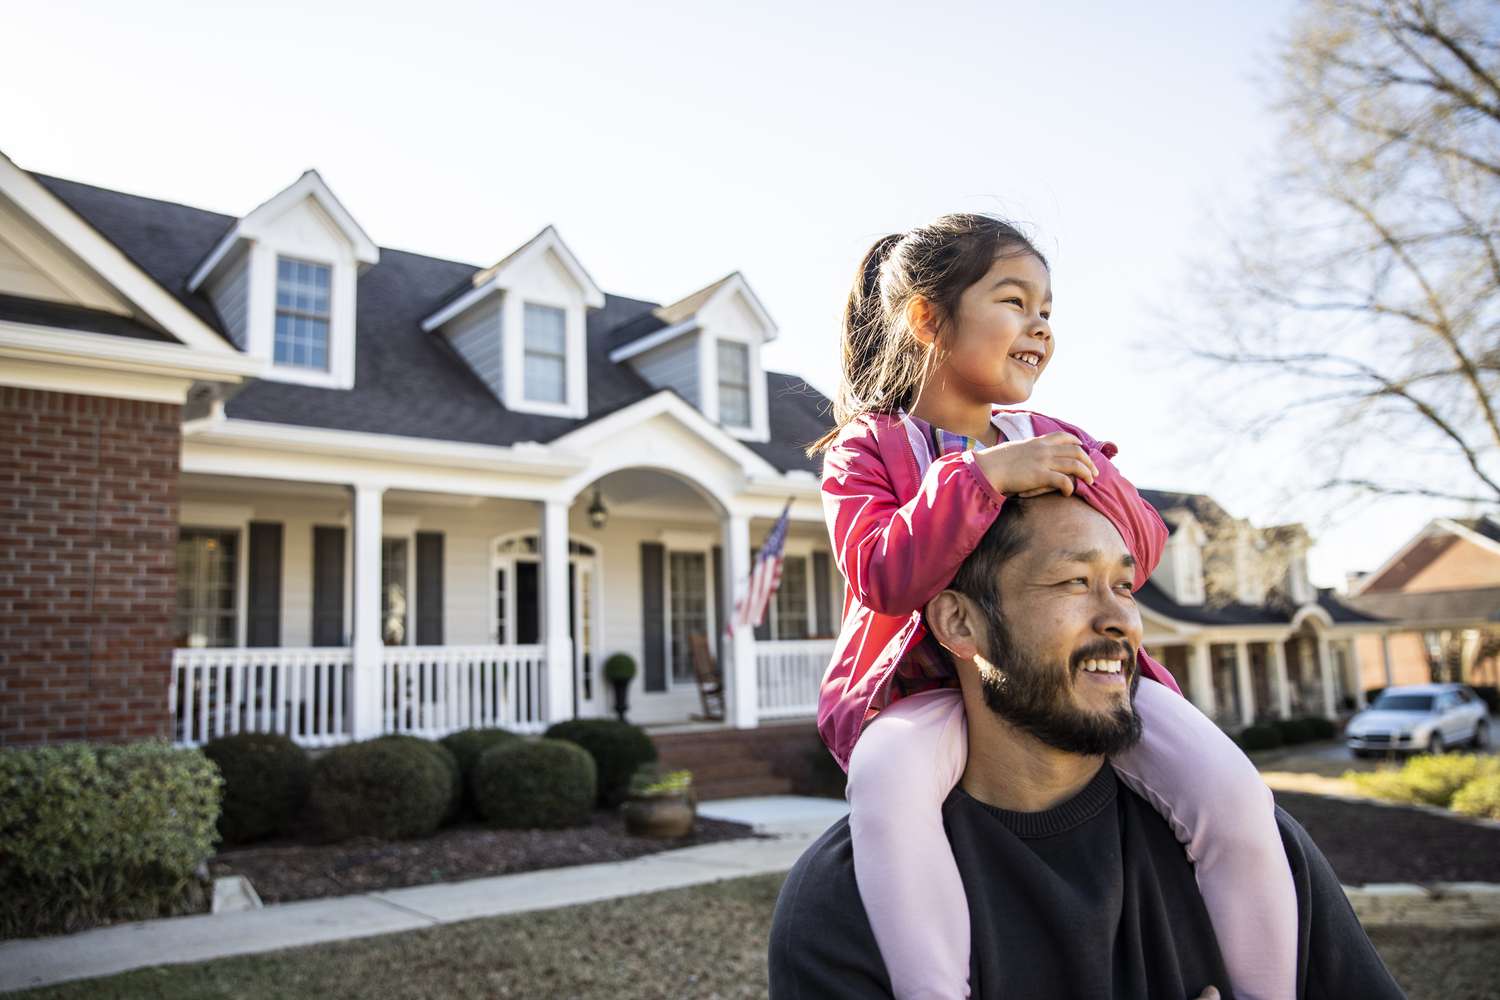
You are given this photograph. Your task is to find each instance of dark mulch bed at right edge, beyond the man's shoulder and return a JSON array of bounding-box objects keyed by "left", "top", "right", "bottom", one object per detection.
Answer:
[{"left": 1277, "top": 792, "right": 1500, "bottom": 885}]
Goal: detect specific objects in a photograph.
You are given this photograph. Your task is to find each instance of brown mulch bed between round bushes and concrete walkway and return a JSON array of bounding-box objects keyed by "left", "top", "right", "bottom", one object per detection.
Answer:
[{"left": 209, "top": 811, "right": 756, "bottom": 903}]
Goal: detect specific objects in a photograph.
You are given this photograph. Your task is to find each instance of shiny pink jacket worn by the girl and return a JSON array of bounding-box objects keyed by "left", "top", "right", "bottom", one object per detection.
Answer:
[{"left": 818, "top": 414, "right": 1181, "bottom": 769}]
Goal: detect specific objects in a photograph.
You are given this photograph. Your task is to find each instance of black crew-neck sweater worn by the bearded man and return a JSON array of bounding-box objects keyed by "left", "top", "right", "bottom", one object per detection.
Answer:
[{"left": 770, "top": 768, "right": 1403, "bottom": 1000}]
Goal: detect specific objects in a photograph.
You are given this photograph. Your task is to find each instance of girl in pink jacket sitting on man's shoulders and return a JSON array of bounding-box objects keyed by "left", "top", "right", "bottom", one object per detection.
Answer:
[{"left": 815, "top": 214, "right": 1298, "bottom": 1000}]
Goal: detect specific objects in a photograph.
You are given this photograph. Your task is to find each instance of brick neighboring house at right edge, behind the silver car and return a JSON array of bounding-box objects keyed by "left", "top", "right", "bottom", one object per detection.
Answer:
[{"left": 1347, "top": 514, "right": 1500, "bottom": 688}]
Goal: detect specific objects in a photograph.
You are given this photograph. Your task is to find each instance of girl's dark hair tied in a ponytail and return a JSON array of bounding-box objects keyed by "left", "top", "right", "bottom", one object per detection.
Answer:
[{"left": 807, "top": 213, "right": 1047, "bottom": 456}]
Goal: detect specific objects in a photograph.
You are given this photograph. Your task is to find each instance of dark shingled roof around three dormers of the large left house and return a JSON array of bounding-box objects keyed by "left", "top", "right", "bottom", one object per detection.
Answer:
[{"left": 36, "top": 174, "right": 831, "bottom": 472}]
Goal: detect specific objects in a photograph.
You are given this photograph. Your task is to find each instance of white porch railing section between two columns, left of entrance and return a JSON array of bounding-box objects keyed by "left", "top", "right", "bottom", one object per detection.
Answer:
[{"left": 381, "top": 646, "right": 548, "bottom": 738}]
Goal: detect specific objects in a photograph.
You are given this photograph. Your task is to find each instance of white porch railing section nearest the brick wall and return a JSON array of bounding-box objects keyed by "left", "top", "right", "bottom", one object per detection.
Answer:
[{"left": 168, "top": 648, "right": 354, "bottom": 747}]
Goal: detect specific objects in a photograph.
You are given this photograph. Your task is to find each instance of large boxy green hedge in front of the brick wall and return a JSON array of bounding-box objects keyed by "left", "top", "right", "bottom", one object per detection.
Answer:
[{"left": 0, "top": 742, "right": 222, "bottom": 937}]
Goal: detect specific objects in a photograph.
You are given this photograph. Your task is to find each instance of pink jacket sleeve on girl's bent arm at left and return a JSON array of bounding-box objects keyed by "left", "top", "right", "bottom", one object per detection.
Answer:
[{"left": 822, "top": 424, "right": 1005, "bottom": 615}]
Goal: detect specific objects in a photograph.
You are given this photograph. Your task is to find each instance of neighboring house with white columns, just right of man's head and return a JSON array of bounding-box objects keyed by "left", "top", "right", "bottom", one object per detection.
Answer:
[{"left": 1137, "top": 490, "right": 1383, "bottom": 729}]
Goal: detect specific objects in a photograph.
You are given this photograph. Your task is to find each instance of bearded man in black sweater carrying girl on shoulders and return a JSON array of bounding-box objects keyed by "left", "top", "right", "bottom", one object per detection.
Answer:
[{"left": 770, "top": 495, "right": 1403, "bottom": 1000}]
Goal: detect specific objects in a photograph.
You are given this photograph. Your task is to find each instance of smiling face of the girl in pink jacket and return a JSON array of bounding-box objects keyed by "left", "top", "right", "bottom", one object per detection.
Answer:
[{"left": 939, "top": 253, "right": 1053, "bottom": 405}]
